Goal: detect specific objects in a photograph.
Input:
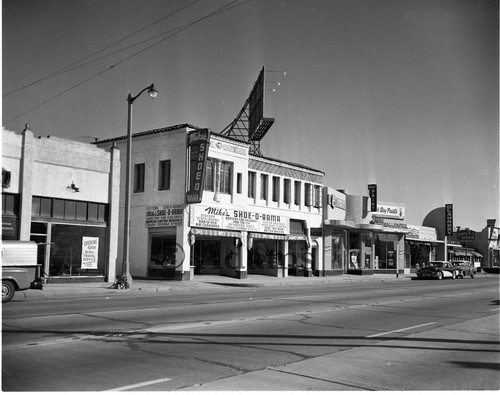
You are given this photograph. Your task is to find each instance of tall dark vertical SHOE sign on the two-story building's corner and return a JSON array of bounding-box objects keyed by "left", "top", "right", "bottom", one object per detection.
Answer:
[{"left": 186, "top": 129, "right": 210, "bottom": 204}]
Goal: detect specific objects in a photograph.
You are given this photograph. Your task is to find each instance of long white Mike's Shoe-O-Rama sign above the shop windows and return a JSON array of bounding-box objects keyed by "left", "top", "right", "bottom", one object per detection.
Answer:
[{"left": 189, "top": 205, "right": 290, "bottom": 234}]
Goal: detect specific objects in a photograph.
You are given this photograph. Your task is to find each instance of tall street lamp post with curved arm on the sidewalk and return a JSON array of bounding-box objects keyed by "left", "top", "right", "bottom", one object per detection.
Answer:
[{"left": 120, "top": 84, "right": 158, "bottom": 288}]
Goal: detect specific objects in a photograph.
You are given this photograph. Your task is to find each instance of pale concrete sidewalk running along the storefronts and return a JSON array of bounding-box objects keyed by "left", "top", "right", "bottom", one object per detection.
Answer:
[{"left": 13, "top": 274, "right": 416, "bottom": 300}]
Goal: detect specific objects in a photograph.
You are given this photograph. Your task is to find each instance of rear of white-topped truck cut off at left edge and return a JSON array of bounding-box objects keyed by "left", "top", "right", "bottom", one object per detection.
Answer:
[{"left": 2, "top": 240, "right": 42, "bottom": 303}]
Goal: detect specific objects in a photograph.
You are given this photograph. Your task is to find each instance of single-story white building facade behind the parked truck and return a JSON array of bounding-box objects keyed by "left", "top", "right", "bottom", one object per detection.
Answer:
[{"left": 2, "top": 127, "right": 120, "bottom": 282}]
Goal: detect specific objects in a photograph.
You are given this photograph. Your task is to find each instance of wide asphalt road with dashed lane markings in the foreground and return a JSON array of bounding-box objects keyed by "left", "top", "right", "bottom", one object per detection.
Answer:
[{"left": 2, "top": 276, "right": 500, "bottom": 391}]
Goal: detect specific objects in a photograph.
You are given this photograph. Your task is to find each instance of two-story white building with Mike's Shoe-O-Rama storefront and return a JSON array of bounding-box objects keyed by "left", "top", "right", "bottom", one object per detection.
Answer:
[{"left": 96, "top": 124, "right": 324, "bottom": 280}]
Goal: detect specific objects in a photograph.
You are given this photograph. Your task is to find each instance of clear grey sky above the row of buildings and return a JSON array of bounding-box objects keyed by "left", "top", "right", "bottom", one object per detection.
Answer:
[{"left": 2, "top": 0, "right": 500, "bottom": 231}]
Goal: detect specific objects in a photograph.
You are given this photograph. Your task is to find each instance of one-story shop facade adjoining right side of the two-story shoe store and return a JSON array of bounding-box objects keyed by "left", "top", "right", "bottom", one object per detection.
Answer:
[{"left": 324, "top": 188, "right": 410, "bottom": 275}]
